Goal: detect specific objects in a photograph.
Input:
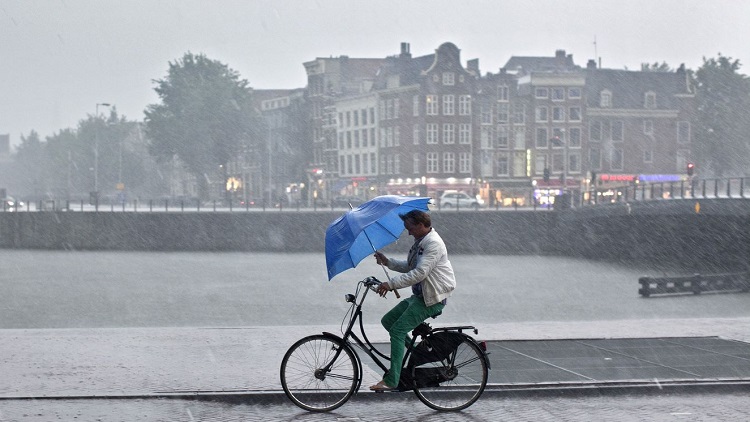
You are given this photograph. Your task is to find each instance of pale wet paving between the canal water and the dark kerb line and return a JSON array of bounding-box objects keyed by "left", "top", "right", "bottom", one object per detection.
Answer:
[{"left": 0, "top": 318, "right": 750, "bottom": 399}]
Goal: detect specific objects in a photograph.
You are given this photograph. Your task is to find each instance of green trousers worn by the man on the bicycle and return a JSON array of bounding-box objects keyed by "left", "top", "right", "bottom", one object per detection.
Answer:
[{"left": 380, "top": 296, "right": 445, "bottom": 387}]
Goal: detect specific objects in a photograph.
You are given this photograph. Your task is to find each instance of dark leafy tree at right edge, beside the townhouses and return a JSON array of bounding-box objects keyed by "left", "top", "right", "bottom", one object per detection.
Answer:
[{"left": 693, "top": 54, "right": 750, "bottom": 177}]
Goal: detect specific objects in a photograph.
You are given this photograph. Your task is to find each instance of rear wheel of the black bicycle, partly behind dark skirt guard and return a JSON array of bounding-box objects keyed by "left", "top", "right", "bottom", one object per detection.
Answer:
[{"left": 412, "top": 338, "right": 488, "bottom": 411}]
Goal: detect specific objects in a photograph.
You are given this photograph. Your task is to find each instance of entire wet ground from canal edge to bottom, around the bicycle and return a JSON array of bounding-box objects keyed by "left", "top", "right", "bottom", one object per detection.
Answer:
[{"left": 0, "top": 318, "right": 750, "bottom": 421}]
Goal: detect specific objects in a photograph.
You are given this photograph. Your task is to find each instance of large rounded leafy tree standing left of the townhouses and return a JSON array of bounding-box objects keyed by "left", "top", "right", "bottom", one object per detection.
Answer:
[{"left": 145, "top": 52, "right": 260, "bottom": 198}]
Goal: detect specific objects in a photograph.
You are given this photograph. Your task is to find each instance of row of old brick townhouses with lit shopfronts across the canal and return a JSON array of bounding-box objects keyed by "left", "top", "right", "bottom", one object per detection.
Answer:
[{"left": 245, "top": 43, "right": 694, "bottom": 205}]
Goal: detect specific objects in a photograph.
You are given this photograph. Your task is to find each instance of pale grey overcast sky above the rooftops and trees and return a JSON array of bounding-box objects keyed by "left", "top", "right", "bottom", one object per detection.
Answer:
[{"left": 0, "top": 0, "right": 750, "bottom": 144}]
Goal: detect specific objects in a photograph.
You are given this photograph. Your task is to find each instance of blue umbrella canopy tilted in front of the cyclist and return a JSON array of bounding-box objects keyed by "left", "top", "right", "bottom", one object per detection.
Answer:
[{"left": 326, "top": 195, "right": 430, "bottom": 280}]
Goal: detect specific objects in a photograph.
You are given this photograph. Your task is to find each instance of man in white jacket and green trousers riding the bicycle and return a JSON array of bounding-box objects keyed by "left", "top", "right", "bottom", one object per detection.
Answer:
[{"left": 370, "top": 210, "right": 456, "bottom": 391}]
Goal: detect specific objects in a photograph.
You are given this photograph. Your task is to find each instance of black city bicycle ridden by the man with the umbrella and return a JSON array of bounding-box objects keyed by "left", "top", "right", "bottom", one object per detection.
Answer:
[{"left": 280, "top": 277, "right": 490, "bottom": 412}]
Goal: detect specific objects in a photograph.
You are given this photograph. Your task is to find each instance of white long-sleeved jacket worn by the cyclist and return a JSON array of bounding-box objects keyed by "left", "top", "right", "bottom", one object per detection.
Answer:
[{"left": 388, "top": 228, "right": 456, "bottom": 306}]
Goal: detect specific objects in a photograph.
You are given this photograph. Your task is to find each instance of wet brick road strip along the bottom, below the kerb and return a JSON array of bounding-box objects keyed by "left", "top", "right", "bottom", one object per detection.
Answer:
[{"left": 0, "top": 391, "right": 750, "bottom": 422}]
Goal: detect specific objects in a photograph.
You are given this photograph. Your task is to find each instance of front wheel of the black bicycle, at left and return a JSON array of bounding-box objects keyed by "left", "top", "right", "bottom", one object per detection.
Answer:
[{"left": 281, "top": 335, "right": 359, "bottom": 412}]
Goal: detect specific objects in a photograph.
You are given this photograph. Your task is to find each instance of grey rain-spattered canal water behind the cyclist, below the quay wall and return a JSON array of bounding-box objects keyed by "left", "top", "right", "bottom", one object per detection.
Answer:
[{"left": 0, "top": 251, "right": 750, "bottom": 329}]
